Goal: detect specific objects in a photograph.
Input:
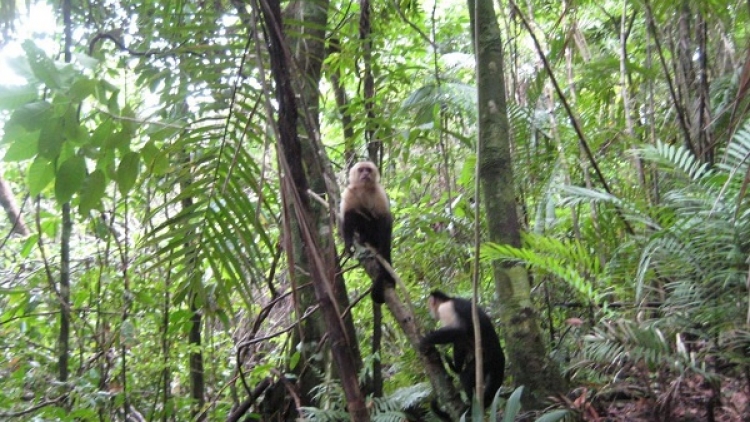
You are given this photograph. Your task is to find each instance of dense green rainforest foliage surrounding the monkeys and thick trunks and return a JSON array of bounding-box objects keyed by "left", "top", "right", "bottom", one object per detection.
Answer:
[{"left": 0, "top": 0, "right": 750, "bottom": 421}]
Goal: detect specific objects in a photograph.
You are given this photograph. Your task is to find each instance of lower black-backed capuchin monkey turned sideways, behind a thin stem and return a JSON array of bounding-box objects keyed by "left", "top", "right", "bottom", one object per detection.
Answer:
[{"left": 420, "top": 290, "right": 505, "bottom": 420}]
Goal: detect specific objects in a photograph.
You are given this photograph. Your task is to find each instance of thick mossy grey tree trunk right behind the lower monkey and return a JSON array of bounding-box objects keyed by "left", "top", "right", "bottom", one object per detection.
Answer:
[{"left": 468, "top": 0, "right": 564, "bottom": 408}]
